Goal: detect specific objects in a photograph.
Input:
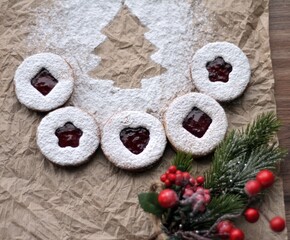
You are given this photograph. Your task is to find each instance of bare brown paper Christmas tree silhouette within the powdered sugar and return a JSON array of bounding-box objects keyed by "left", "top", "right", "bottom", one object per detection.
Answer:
[{"left": 90, "top": 5, "right": 166, "bottom": 88}]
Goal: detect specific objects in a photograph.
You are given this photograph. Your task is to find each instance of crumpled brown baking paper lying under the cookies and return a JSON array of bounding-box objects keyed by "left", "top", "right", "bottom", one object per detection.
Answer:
[{"left": 0, "top": 0, "right": 287, "bottom": 240}]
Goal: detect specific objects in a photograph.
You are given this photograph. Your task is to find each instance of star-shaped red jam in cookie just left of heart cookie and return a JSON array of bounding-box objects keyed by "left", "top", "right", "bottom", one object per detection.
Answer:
[{"left": 55, "top": 122, "right": 83, "bottom": 148}]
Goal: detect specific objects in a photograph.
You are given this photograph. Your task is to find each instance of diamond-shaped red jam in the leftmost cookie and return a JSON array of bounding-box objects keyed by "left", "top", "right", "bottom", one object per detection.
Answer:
[{"left": 31, "top": 68, "right": 58, "bottom": 96}]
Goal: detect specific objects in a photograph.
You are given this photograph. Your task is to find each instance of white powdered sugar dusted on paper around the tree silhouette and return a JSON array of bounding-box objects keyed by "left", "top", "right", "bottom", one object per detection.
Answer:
[{"left": 28, "top": 0, "right": 211, "bottom": 124}]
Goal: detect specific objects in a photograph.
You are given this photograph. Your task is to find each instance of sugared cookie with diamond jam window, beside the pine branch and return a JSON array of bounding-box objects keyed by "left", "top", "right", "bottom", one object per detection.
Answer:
[{"left": 164, "top": 93, "right": 228, "bottom": 156}]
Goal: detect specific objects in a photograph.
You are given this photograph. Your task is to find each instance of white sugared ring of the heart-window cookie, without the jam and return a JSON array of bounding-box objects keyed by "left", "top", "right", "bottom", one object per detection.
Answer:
[{"left": 101, "top": 111, "right": 166, "bottom": 170}]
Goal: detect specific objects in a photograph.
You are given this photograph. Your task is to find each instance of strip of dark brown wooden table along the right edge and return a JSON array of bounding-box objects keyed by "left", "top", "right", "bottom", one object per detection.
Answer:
[{"left": 269, "top": 0, "right": 290, "bottom": 236}]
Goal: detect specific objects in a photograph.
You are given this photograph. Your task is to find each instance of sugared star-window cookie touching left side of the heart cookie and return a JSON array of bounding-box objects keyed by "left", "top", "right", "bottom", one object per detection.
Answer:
[{"left": 37, "top": 107, "right": 99, "bottom": 166}]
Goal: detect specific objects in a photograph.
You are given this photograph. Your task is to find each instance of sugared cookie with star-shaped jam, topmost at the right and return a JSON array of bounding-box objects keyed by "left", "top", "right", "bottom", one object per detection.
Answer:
[{"left": 191, "top": 42, "right": 251, "bottom": 101}]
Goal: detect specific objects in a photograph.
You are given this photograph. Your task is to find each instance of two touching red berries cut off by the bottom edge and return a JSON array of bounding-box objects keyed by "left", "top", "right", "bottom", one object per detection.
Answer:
[{"left": 216, "top": 220, "right": 245, "bottom": 240}]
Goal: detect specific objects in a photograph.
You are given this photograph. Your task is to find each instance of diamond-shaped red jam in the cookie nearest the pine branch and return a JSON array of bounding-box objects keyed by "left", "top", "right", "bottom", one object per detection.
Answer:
[{"left": 182, "top": 107, "right": 212, "bottom": 138}]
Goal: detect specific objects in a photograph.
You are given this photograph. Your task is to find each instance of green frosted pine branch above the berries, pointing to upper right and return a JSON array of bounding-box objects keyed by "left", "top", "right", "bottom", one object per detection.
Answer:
[{"left": 205, "top": 113, "right": 285, "bottom": 197}]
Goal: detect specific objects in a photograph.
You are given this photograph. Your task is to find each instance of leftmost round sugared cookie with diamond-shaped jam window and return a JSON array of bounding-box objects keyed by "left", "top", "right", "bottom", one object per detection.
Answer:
[{"left": 14, "top": 53, "right": 74, "bottom": 111}]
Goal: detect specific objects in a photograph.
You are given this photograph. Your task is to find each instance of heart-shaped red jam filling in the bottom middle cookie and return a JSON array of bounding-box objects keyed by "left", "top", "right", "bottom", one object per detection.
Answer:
[{"left": 120, "top": 127, "right": 150, "bottom": 154}]
